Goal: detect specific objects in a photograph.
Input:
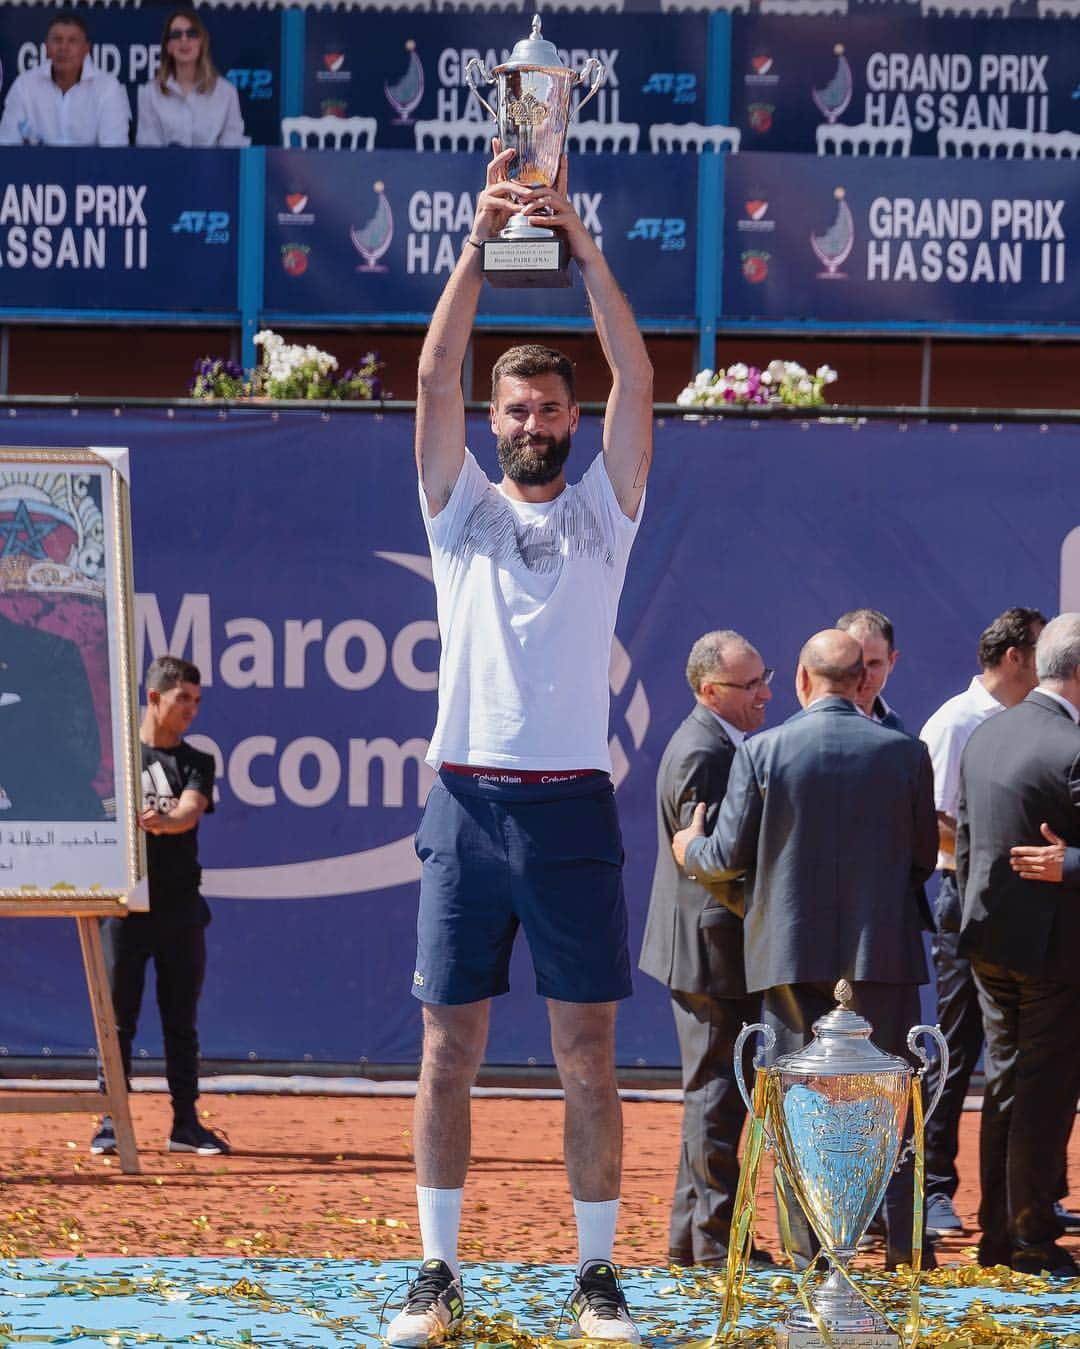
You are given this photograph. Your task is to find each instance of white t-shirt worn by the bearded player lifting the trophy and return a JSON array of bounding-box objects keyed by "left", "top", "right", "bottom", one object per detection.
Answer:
[{"left": 421, "top": 449, "right": 644, "bottom": 772}]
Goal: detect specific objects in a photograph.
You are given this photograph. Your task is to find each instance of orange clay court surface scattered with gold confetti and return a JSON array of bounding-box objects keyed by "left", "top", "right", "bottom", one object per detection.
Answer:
[{"left": 0, "top": 1093, "right": 1080, "bottom": 1265}]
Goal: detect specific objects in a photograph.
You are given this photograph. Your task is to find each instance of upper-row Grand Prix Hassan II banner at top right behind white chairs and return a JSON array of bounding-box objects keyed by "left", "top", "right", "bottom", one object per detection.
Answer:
[{"left": 731, "top": 8, "right": 1080, "bottom": 155}]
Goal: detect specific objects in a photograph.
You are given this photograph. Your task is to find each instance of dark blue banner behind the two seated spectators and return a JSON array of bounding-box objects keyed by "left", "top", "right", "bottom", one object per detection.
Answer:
[{"left": 0, "top": 4, "right": 282, "bottom": 146}]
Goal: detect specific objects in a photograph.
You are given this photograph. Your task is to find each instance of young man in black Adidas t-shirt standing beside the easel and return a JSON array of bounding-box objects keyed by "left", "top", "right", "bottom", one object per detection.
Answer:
[{"left": 90, "top": 656, "right": 229, "bottom": 1156}]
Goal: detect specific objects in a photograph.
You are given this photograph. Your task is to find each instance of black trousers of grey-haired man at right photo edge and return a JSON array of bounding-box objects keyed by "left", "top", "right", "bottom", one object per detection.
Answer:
[{"left": 972, "top": 960, "right": 1080, "bottom": 1263}]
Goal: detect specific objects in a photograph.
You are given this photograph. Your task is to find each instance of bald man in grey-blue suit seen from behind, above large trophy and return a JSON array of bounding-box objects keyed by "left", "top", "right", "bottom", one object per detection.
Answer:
[{"left": 671, "top": 629, "right": 937, "bottom": 1265}]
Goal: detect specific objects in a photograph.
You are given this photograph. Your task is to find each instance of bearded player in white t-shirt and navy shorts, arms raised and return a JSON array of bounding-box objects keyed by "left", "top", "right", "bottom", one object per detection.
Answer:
[{"left": 387, "top": 142, "right": 653, "bottom": 1346}]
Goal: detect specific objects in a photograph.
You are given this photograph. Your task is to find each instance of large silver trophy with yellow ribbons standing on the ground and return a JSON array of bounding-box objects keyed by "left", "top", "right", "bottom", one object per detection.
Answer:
[{"left": 735, "top": 979, "right": 949, "bottom": 1349}]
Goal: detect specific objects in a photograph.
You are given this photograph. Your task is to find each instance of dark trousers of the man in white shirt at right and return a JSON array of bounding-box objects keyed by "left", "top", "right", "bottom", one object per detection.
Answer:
[{"left": 926, "top": 871, "right": 983, "bottom": 1198}]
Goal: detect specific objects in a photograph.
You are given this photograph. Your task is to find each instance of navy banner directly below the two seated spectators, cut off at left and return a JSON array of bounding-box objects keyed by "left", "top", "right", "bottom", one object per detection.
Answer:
[{"left": 0, "top": 147, "right": 240, "bottom": 313}]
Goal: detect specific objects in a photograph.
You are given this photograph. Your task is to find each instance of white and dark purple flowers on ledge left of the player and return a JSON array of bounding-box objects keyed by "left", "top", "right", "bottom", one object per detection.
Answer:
[{"left": 189, "top": 328, "right": 383, "bottom": 401}]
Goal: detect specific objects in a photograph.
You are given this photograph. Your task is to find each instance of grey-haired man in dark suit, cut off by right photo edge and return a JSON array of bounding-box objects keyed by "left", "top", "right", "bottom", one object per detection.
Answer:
[{"left": 956, "top": 614, "right": 1080, "bottom": 1278}]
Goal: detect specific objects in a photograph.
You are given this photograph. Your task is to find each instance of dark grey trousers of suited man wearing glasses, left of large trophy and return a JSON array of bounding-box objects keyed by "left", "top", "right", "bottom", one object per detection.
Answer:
[{"left": 667, "top": 989, "right": 760, "bottom": 1264}]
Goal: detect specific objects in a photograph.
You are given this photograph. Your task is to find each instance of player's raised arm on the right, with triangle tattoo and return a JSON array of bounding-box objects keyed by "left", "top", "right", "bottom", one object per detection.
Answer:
[{"left": 541, "top": 155, "right": 653, "bottom": 519}]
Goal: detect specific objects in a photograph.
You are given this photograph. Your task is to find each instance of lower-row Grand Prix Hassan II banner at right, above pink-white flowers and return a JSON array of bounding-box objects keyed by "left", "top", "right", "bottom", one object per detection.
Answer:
[{"left": 720, "top": 155, "right": 1080, "bottom": 324}]
